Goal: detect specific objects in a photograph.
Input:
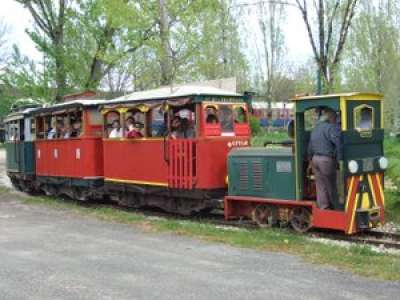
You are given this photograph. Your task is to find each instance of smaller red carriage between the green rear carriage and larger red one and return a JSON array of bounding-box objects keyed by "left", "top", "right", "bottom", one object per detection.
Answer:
[{"left": 32, "top": 100, "right": 103, "bottom": 200}]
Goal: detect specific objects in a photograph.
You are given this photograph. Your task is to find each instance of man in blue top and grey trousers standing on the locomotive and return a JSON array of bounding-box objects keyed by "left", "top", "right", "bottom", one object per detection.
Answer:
[{"left": 308, "top": 110, "right": 342, "bottom": 209}]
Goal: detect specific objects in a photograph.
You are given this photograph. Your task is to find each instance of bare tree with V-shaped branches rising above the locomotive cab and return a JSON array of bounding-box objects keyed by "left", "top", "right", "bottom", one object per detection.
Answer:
[{"left": 296, "top": 0, "right": 359, "bottom": 92}]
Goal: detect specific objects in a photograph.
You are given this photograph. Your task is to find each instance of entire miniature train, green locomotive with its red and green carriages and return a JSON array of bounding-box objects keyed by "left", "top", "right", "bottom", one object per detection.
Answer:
[{"left": 5, "top": 86, "right": 388, "bottom": 234}]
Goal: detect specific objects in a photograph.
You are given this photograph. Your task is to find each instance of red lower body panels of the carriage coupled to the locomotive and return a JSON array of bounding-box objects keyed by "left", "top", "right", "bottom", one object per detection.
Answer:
[{"left": 104, "top": 137, "right": 248, "bottom": 189}]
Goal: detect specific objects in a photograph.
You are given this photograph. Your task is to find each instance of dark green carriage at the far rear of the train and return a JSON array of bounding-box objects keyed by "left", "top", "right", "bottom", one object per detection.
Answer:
[{"left": 4, "top": 107, "right": 38, "bottom": 192}]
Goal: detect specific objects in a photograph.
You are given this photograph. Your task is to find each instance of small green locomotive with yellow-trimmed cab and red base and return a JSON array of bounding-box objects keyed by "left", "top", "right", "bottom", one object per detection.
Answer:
[{"left": 225, "top": 93, "right": 388, "bottom": 234}]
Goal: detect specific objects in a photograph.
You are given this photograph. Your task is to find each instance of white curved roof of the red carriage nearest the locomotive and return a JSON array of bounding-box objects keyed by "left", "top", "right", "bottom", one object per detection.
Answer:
[{"left": 107, "top": 85, "right": 243, "bottom": 104}]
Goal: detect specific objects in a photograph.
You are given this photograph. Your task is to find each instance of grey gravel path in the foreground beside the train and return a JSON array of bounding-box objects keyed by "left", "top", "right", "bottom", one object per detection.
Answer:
[{"left": 0, "top": 149, "right": 400, "bottom": 300}]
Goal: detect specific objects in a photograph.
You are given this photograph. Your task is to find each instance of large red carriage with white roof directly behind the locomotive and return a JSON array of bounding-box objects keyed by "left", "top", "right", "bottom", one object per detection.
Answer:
[{"left": 102, "top": 85, "right": 250, "bottom": 214}]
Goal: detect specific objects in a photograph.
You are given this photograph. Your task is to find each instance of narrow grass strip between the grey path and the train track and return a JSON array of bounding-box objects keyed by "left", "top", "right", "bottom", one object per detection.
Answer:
[{"left": 0, "top": 189, "right": 400, "bottom": 280}]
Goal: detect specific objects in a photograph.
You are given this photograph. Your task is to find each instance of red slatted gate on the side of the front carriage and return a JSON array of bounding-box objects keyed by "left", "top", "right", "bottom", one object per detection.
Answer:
[{"left": 168, "top": 139, "right": 196, "bottom": 189}]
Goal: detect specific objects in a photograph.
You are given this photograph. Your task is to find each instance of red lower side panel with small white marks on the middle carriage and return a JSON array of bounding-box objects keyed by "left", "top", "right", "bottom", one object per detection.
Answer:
[{"left": 35, "top": 137, "right": 103, "bottom": 178}]
